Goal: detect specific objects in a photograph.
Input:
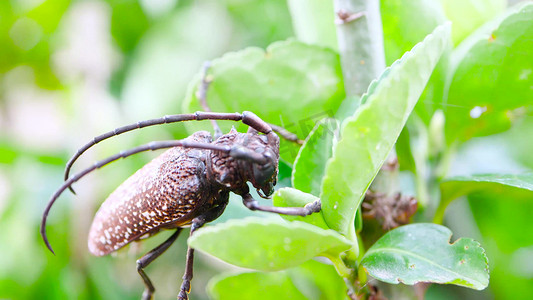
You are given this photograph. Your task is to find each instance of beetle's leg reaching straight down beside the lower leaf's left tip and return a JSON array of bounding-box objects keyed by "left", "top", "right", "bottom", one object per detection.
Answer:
[{"left": 178, "top": 202, "right": 229, "bottom": 300}]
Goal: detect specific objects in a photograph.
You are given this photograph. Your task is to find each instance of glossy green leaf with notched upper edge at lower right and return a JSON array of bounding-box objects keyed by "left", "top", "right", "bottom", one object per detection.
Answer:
[{"left": 361, "top": 224, "right": 489, "bottom": 290}]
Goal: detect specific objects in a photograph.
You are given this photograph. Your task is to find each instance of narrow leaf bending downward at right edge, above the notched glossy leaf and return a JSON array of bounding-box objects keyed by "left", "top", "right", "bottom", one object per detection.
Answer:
[{"left": 434, "top": 173, "right": 533, "bottom": 223}]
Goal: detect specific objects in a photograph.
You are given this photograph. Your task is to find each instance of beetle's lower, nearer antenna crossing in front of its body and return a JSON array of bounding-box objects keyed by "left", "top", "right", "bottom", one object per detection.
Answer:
[{"left": 41, "top": 141, "right": 233, "bottom": 254}]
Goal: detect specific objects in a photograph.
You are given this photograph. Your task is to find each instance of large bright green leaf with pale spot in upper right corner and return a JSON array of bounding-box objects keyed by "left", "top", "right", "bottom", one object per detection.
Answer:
[{"left": 445, "top": 2, "right": 533, "bottom": 143}]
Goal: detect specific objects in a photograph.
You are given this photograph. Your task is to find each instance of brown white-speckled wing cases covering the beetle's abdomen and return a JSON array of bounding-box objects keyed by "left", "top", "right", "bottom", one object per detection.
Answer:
[{"left": 88, "top": 132, "right": 221, "bottom": 256}]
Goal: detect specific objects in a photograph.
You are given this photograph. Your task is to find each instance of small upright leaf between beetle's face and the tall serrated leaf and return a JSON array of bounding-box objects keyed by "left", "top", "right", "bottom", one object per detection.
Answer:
[{"left": 292, "top": 119, "right": 338, "bottom": 196}]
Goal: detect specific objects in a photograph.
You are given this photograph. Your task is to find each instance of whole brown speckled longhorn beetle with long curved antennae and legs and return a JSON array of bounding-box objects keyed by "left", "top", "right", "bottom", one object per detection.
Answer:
[{"left": 41, "top": 64, "right": 320, "bottom": 300}]
